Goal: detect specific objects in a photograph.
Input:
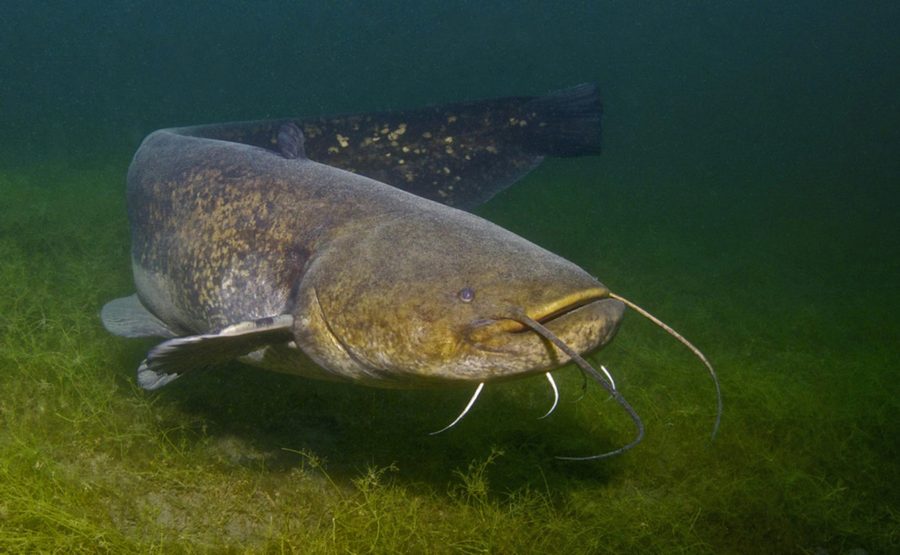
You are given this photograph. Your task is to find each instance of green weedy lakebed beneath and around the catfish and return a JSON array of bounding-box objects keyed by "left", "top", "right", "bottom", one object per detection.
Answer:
[{"left": 0, "top": 159, "right": 900, "bottom": 553}]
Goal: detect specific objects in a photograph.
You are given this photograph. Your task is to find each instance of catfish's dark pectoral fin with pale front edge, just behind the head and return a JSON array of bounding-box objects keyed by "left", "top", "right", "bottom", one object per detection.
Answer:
[{"left": 137, "top": 314, "right": 294, "bottom": 390}]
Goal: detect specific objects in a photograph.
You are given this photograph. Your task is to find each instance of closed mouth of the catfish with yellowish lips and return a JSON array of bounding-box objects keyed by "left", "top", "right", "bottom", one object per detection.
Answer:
[{"left": 469, "top": 287, "right": 610, "bottom": 343}]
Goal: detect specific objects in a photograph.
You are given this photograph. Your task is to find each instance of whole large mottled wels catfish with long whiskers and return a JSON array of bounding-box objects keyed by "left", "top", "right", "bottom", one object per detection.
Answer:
[{"left": 101, "top": 85, "right": 721, "bottom": 459}]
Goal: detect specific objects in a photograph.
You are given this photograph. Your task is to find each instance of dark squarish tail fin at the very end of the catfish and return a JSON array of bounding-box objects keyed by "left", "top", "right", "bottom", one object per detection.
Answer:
[{"left": 522, "top": 83, "right": 603, "bottom": 157}]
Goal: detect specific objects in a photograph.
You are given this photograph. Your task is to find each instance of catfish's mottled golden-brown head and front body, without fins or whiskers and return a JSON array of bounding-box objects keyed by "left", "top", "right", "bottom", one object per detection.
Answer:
[{"left": 128, "top": 128, "right": 623, "bottom": 387}]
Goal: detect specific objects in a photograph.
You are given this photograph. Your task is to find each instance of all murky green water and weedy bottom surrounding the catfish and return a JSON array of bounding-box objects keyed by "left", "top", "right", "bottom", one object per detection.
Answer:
[{"left": 0, "top": 2, "right": 900, "bottom": 553}]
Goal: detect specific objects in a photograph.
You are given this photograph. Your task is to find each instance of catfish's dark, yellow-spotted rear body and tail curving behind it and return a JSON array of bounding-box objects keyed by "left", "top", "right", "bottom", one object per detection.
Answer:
[{"left": 188, "top": 84, "right": 601, "bottom": 208}]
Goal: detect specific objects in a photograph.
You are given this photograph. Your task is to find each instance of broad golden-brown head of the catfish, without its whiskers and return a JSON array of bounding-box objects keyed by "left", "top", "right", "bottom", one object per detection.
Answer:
[{"left": 294, "top": 207, "right": 625, "bottom": 387}]
